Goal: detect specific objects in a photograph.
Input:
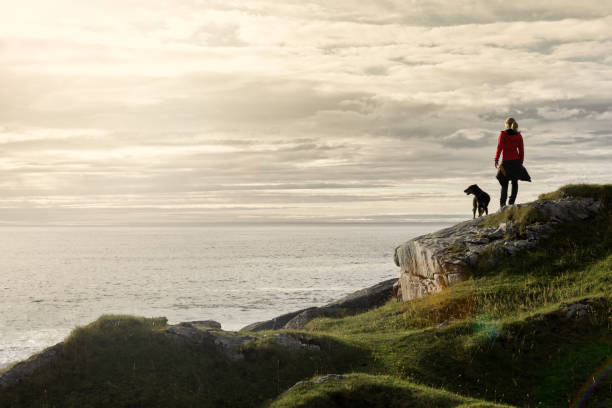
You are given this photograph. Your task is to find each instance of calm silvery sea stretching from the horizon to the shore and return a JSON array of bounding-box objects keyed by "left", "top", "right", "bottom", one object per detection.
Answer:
[{"left": 0, "top": 224, "right": 448, "bottom": 368}]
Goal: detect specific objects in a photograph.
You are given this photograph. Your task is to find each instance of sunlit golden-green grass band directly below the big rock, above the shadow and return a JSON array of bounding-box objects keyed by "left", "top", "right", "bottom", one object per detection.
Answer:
[{"left": 308, "top": 204, "right": 612, "bottom": 332}]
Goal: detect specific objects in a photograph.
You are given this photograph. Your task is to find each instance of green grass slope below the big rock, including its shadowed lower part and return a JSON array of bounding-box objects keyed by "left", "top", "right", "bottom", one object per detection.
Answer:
[{"left": 307, "top": 184, "right": 612, "bottom": 407}]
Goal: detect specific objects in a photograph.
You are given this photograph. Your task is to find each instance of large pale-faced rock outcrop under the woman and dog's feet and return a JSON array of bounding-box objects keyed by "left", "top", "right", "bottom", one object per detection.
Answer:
[{"left": 393, "top": 198, "right": 602, "bottom": 300}]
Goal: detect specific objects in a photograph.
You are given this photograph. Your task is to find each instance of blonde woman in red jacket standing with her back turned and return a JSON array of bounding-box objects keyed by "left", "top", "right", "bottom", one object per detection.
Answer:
[{"left": 495, "top": 118, "right": 531, "bottom": 208}]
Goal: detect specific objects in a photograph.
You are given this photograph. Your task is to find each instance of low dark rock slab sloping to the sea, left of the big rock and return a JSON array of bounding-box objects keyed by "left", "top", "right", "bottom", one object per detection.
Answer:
[{"left": 240, "top": 278, "right": 397, "bottom": 331}]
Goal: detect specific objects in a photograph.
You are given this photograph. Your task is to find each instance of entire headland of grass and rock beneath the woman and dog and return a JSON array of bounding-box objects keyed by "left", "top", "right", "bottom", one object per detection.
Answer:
[{"left": 0, "top": 185, "right": 612, "bottom": 408}]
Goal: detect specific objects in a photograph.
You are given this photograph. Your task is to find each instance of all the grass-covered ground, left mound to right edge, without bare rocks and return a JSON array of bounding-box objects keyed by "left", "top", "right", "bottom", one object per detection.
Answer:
[{"left": 0, "top": 185, "right": 612, "bottom": 408}]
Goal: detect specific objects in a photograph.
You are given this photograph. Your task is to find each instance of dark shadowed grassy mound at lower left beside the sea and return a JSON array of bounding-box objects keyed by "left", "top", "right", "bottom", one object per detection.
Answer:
[{"left": 0, "top": 315, "right": 360, "bottom": 408}]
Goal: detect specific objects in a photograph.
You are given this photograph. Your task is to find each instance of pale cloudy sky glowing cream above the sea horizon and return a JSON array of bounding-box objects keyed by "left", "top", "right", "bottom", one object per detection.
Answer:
[{"left": 0, "top": 0, "right": 612, "bottom": 225}]
